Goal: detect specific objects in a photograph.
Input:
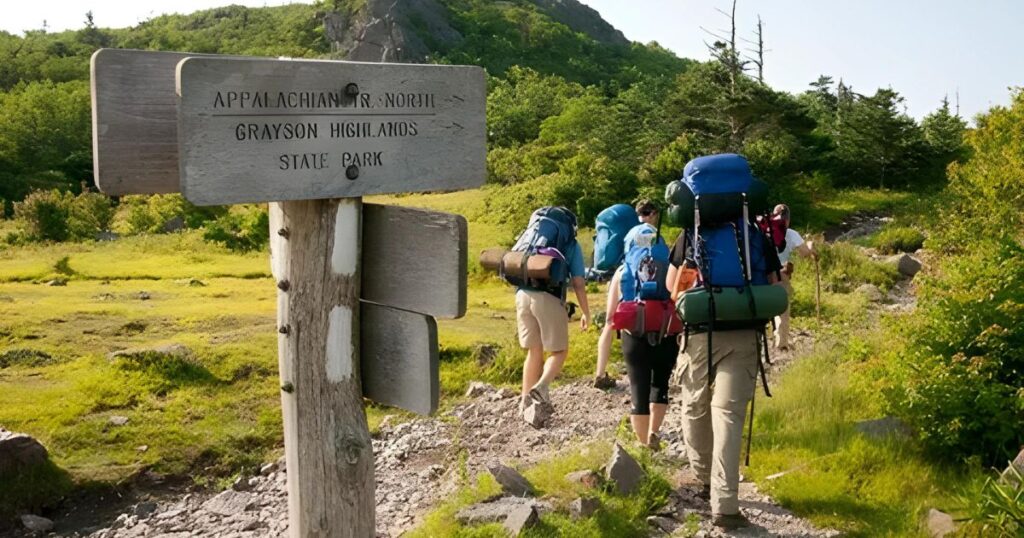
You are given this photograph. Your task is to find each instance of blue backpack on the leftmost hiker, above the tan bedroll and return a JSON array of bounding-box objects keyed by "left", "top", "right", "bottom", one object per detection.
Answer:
[{"left": 502, "top": 206, "right": 577, "bottom": 296}]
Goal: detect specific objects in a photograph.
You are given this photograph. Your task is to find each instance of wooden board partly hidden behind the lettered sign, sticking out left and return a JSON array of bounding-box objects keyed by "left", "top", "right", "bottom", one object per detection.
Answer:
[{"left": 90, "top": 48, "right": 224, "bottom": 196}]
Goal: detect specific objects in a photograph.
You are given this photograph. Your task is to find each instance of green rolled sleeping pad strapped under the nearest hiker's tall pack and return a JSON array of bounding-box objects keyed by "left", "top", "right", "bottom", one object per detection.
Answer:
[{"left": 676, "top": 286, "right": 790, "bottom": 324}]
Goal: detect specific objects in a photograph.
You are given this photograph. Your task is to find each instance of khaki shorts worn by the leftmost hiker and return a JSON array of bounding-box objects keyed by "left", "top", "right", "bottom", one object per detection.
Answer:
[{"left": 515, "top": 290, "right": 569, "bottom": 353}]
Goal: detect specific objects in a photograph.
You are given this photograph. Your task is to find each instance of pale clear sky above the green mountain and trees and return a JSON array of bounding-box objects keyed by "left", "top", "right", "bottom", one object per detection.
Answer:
[{"left": 0, "top": 0, "right": 1024, "bottom": 119}]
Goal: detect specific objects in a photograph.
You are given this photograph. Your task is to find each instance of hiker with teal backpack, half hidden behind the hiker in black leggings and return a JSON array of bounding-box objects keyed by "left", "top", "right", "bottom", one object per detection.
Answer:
[{"left": 590, "top": 199, "right": 660, "bottom": 389}]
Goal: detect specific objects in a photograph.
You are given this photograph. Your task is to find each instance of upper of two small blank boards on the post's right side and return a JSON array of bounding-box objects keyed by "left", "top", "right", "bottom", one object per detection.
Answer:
[{"left": 359, "top": 204, "right": 468, "bottom": 319}]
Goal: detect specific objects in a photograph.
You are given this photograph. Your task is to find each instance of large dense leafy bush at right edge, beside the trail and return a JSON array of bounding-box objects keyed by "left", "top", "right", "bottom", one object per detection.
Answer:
[{"left": 887, "top": 240, "right": 1024, "bottom": 464}]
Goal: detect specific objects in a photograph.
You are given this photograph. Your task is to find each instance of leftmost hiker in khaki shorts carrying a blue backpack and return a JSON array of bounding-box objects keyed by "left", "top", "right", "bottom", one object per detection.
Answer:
[{"left": 513, "top": 207, "right": 590, "bottom": 420}]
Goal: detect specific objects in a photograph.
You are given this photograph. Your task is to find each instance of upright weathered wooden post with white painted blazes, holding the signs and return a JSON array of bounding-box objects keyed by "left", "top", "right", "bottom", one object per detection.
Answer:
[{"left": 270, "top": 199, "right": 375, "bottom": 538}]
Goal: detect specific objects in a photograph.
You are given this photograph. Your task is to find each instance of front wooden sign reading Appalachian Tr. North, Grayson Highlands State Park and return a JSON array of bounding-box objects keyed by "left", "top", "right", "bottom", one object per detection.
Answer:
[{"left": 177, "top": 57, "right": 486, "bottom": 205}]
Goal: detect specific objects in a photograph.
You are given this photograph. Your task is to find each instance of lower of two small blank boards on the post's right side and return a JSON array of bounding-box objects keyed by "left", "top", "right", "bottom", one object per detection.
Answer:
[{"left": 359, "top": 302, "right": 440, "bottom": 415}]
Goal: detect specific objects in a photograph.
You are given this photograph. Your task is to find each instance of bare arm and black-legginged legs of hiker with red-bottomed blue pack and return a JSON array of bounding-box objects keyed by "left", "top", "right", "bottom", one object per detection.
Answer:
[{"left": 607, "top": 261, "right": 679, "bottom": 450}]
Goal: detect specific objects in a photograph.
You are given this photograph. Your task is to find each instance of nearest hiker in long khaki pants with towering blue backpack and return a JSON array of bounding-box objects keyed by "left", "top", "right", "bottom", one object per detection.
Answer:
[{"left": 666, "top": 154, "right": 787, "bottom": 529}]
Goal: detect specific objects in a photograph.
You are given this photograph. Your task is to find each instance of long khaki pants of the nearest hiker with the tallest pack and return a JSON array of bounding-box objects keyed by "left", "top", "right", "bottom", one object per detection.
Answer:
[{"left": 679, "top": 330, "right": 758, "bottom": 514}]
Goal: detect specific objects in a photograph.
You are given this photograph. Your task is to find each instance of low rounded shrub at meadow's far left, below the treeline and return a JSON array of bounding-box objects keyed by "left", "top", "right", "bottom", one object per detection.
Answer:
[{"left": 14, "top": 190, "right": 114, "bottom": 241}]
